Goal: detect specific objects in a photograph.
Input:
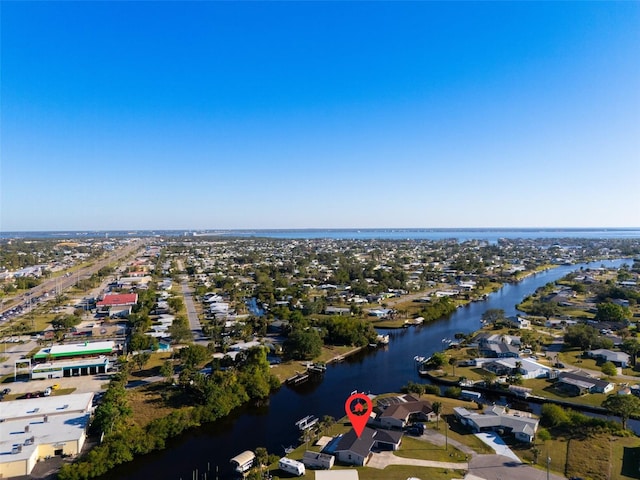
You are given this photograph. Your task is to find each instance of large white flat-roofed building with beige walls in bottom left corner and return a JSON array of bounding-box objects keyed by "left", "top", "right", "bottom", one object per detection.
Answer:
[{"left": 0, "top": 393, "right": 93, "bottom": 478}]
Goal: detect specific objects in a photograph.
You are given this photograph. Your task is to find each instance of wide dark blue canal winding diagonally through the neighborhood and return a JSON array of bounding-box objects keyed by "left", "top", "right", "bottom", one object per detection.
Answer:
[{"left": 103, "top": 260, "right": 630, "bottom": 480}]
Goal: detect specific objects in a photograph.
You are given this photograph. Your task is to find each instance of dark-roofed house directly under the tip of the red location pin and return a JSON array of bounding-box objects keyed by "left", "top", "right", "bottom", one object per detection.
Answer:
[{"left": 334, "top": 427, "right": 402, "bottom": 467}]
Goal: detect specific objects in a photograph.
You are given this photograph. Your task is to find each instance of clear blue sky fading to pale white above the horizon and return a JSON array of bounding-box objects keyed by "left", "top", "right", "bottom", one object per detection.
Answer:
[{"left": 0, "top": 1, "right": 640, "bottom": 231}]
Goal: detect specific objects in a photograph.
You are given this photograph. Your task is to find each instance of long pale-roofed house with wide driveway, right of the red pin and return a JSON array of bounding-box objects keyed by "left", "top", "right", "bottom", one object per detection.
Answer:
[{"left": 453, "top": 406, "right": 539, "bottom": 443}]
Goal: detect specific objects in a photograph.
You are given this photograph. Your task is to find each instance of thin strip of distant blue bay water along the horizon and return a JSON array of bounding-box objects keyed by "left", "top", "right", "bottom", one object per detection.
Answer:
[{"left": 0, "top": 227, "right": 640, "bottom": 243}]
